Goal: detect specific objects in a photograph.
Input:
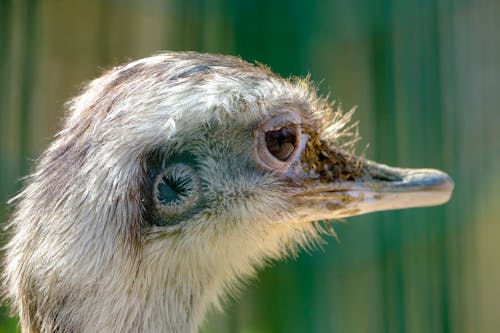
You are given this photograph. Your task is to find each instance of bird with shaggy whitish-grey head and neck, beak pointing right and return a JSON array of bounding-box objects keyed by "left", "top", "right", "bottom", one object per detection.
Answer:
[{"left": 3, "top": 51, "right": 454, "bottom": 333}]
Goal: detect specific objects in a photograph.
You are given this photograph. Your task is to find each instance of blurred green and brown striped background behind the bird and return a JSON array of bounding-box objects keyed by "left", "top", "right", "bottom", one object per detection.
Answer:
[{"left": 0, "top": 0, "right": 500, "bottom": 333}]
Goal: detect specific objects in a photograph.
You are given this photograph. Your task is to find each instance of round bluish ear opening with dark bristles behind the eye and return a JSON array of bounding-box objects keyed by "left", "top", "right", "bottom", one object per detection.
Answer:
[{"left": 153, "top": 163, "right": 199, "bottom": 224}]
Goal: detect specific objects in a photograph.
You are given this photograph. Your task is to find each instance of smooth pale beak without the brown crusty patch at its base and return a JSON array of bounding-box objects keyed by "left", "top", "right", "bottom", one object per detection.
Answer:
[{"left": 296, "top": 161, "right": 454, "bottom": 220}]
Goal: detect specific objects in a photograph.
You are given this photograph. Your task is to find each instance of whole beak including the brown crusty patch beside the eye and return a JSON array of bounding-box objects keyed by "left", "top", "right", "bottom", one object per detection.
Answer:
[{"left": 292, "top": 127, "right": 454, "bottom": 220}]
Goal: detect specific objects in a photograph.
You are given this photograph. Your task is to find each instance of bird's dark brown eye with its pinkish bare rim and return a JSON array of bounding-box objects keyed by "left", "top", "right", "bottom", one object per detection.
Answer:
[{"left": 255, "top": 114, "right": 301, "bottom": 171}]
